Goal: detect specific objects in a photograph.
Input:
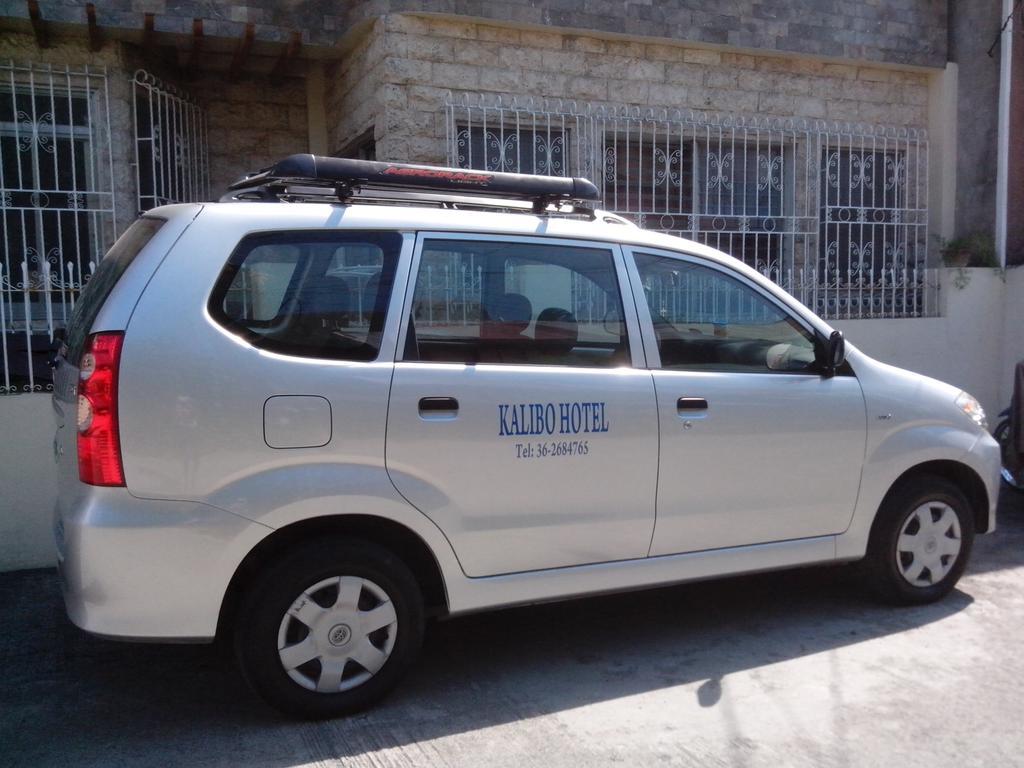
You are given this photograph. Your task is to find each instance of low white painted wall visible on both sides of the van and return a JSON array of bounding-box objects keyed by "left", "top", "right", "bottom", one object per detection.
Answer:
[{"left": 0, "top": 268, "right": 1024, "bottom": 571}]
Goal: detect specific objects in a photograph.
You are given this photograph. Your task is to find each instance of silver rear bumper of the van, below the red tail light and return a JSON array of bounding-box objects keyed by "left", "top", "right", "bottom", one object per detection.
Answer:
[{"left": 53, "top": 486, "right": 270, "bottom": 642}]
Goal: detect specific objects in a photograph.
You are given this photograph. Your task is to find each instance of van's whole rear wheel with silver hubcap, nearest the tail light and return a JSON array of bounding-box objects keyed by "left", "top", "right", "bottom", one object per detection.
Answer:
[{"left": 234, "top": 539, "right": 423, "bottom": 718}]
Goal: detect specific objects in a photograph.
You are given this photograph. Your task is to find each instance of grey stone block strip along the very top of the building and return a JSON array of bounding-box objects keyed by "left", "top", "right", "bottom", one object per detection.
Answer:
[{"left": 9, "top": 0, "right": 950, "bottom": 67}]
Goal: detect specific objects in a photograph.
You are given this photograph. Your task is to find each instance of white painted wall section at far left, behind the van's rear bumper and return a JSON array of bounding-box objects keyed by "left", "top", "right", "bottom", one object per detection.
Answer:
[{"left": 0, "top": 393, "right": 57, "bottom": 571}]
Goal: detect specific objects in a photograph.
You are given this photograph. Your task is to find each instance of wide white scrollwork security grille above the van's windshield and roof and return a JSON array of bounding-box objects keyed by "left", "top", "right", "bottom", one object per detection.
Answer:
[{"left": 445, "top": 94, "right": 936, "bottom": 318}]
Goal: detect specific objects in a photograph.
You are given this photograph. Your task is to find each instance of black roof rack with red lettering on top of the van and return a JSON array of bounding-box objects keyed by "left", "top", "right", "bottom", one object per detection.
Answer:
[{"left": 222, "top": 155, "right": 601, "bottom": 216}]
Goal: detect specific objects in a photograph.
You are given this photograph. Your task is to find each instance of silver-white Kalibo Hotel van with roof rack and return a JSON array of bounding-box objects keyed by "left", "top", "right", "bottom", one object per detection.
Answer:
[{"left": 53, "top": 156, "right": 999, "bottom": 717}]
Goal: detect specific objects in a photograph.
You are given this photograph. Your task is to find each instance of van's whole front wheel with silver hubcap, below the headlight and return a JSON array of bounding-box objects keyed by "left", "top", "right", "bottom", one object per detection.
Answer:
[{"left": 866, "top": 475, "right": 974, "bottom": 604}]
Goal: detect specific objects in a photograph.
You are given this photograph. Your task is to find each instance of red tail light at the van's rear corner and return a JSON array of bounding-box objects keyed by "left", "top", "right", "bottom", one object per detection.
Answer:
[{"left": 78, "top": 333, "right": 125, "bottom": 485}]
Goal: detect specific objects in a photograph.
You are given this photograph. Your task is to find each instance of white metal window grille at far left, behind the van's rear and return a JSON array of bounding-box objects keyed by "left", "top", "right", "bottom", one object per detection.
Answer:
[{"left": 0, "top": 61, "right": 116, "bottom": 394}]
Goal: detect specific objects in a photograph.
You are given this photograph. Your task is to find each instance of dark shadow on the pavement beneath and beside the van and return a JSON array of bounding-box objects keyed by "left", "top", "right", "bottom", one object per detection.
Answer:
[{"left": 0, "top": 495, "right": 1024, "bottom": 767}]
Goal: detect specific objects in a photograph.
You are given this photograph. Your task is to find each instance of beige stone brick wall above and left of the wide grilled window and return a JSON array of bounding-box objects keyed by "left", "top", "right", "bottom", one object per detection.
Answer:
[{"left": 370, "top": 14, "right": 928, "bottom": 163}]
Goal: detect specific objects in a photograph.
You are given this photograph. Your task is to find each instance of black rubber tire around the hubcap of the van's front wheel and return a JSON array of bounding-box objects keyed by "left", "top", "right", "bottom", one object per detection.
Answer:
[{"left": 864, "top": 475, "right": 974, "bottom": 605}]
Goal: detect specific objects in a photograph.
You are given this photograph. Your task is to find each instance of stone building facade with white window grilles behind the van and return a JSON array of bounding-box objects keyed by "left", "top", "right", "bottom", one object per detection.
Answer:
[{"left": 0, "top": 0, "right": 1024, "bottom": 573}]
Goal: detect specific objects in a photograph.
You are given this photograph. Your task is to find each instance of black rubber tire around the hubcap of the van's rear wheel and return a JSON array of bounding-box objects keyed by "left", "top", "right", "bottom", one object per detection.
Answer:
[{"left": 233, "top": 538, "right": 424, "bottom": 719}]
